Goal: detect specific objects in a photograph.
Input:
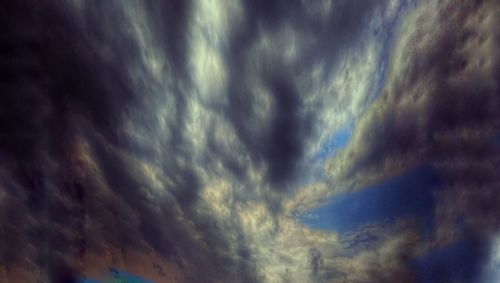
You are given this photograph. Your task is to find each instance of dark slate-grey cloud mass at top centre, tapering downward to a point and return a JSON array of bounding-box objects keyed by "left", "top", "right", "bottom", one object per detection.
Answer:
[{"left": 223, "top": 1, "right": 390, "bottom": 189}]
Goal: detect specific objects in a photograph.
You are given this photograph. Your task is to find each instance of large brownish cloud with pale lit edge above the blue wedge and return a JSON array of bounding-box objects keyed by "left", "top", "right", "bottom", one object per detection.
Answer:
[{"left": 320, "top": 1, "right": 499, "bottom": 280}]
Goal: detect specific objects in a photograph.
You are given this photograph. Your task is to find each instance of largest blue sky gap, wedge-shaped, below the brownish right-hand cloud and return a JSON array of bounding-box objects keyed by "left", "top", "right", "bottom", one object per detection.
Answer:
[{"left": 303, "top": 165, "right": 439, "bottom": 236}]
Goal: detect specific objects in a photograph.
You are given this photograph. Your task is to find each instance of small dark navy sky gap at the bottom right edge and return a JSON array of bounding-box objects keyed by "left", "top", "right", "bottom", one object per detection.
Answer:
[{"left": 411, "top": 237, "right": 483, "bottom": 283}]
